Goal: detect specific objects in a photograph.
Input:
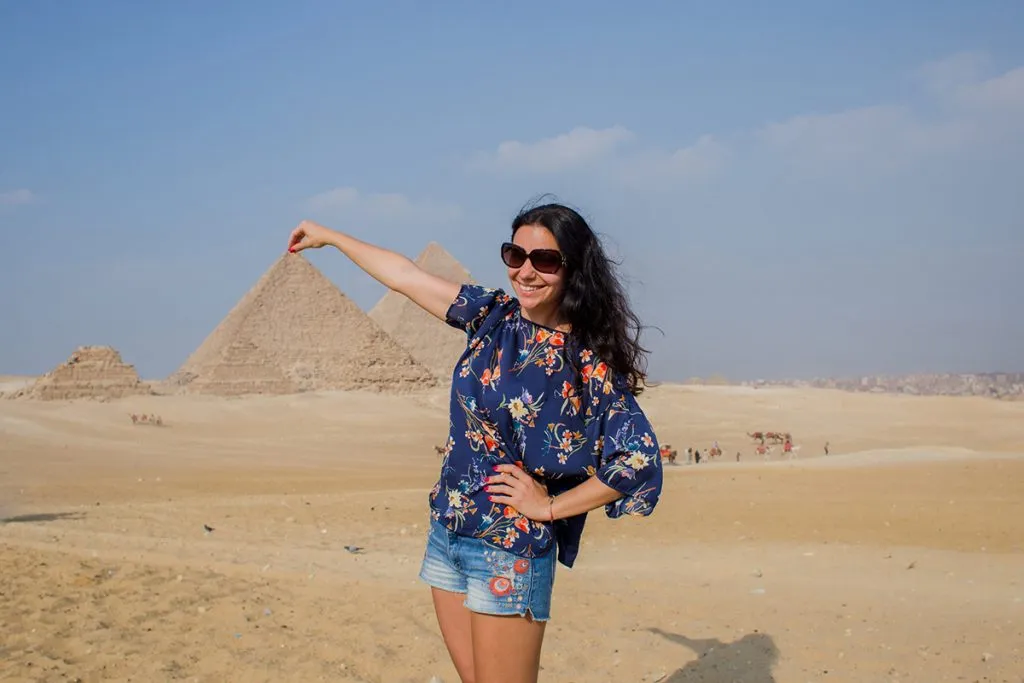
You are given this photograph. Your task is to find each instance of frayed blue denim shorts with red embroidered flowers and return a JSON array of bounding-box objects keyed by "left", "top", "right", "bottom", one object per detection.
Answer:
[{"left": 420, "top": 520, "right": 557, "bottom": 622}]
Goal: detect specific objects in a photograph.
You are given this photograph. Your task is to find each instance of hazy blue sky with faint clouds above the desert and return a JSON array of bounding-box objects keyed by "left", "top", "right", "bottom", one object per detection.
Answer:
[{"left": 0, "top": 0, "right": 1024, "bottom": 380}]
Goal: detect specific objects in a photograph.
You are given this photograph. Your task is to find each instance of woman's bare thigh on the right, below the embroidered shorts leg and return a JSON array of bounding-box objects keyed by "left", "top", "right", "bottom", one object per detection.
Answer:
[{"left": 470, "top": 612, "right": 546, "bottom": 683}]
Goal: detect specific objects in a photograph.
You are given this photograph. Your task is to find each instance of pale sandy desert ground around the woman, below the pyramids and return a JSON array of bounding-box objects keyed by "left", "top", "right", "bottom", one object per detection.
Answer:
[{"left": 0, "top": 386, "right": 1024, "bottom": 683}]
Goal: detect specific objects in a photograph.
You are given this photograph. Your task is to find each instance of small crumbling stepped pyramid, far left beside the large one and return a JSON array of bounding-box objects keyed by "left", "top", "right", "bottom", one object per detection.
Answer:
[{"left": 9, "top": 346, "right": 153, "bottom": 400}]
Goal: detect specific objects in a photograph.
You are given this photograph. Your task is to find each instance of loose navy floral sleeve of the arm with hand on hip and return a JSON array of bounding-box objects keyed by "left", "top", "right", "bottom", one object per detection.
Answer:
[{"left": 594, "top": 391, "right": 663, "bottom": 517}]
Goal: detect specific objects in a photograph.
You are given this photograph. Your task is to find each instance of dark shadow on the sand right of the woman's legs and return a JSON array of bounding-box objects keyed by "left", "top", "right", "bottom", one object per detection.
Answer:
[{"left": 647, "top": 629, "right": 778, "bottom": 683}]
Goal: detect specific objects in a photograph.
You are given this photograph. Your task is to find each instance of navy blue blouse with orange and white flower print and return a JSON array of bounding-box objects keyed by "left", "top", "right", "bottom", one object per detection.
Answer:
[{"left": 430, "top": 285, "right": 662, "bottom": 566}]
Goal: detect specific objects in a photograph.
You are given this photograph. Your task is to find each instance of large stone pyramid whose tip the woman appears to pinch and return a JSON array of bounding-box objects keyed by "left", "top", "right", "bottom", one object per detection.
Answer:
[{"left": 168, "top": 254, "right": 436, "bottom": 395}]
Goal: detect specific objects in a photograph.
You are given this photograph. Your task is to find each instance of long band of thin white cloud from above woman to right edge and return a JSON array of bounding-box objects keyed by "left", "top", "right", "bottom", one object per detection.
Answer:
[{"left": 471, "top": 52, "right": 1024, "bottom": 189}]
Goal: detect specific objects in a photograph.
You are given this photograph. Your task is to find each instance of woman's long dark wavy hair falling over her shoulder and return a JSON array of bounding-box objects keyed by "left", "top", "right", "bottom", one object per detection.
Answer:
[{"left": 512, "top": 204, "right": 647, "bottom": 395}]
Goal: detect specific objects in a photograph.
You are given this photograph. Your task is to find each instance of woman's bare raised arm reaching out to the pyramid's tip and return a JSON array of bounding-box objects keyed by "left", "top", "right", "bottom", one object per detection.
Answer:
[{"left": 288, "top": 220, "right": 462, "bottom": 321}]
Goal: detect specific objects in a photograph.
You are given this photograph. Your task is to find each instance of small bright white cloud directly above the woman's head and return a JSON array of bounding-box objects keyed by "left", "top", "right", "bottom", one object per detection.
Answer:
[{"left": 471, "top": 126, "right": 633, "bottom": 173}]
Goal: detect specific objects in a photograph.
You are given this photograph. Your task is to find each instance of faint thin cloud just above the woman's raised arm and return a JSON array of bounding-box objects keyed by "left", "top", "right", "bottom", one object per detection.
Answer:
[{"left": 306, "top": 186, "right": 462, "bottom": 224}]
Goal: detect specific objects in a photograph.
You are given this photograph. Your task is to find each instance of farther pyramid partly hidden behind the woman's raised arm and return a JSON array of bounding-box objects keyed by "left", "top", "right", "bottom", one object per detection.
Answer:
[{"left": 370, "top": 242, "right": 473, "bottom": 381}]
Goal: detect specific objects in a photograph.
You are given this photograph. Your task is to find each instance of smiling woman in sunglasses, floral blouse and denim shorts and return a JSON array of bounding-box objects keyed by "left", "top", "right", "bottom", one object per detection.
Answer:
[{"left": 289, "top": 204, "right": 662, "bottom": 683}]
